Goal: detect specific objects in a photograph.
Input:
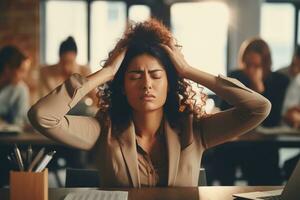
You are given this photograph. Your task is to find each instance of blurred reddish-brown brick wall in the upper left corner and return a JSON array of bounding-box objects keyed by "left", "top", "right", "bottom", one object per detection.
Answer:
[{"left": 0, "top": 0, "right": 40, "bottom": 101}]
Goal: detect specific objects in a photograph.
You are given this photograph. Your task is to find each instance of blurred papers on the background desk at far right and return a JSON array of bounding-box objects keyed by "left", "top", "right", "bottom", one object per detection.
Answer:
[{"left": 255, "top": 125, "right": 300, "bottom": 135}]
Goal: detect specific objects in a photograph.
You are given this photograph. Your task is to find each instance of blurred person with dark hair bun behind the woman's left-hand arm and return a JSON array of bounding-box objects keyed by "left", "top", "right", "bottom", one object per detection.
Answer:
[{"left": 40, "top": 36, "right": 97, "bottom": 115}]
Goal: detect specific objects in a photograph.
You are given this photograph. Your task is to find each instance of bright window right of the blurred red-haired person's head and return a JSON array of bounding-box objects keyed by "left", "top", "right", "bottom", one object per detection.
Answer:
[{"left": 260, "top": 3, "right": 295, "bottom": 71}]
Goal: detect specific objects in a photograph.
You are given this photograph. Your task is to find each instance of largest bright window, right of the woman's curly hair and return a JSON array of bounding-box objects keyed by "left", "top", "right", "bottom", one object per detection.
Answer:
[{"left": 171, "top": 2, "right": 229, "bottom": 75}]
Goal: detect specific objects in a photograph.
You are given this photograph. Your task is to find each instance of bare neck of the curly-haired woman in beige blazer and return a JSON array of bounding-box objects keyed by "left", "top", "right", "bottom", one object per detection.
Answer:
[{"left": 133, "top": 108, "right": 163, "bottom": 138}]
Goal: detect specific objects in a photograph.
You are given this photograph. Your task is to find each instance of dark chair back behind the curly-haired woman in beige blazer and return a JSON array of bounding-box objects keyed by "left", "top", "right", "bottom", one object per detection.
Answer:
[{"left": 65, "top": 168, "right": 207, "bottom": 187}]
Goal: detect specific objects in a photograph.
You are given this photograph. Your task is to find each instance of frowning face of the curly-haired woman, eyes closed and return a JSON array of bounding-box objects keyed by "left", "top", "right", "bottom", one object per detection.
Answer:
[{"left": 124, "top": 54, "right": 168, "bottom": 112}]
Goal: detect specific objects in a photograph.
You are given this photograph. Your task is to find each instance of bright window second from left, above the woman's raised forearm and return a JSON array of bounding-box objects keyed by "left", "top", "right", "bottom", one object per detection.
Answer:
[{"left": 90, "top": 1, "right": 126, "bottom": 72}]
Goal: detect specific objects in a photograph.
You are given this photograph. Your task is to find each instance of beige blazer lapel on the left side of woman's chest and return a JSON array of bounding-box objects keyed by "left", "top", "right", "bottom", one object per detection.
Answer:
[{"left": 118, "top": 122, "right": 141, "bottom": 187}]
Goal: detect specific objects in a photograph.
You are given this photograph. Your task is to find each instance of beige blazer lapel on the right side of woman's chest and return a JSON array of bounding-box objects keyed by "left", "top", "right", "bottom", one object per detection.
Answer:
[{"left": 164, "top": 120, "right": 181, "bottom": 186}]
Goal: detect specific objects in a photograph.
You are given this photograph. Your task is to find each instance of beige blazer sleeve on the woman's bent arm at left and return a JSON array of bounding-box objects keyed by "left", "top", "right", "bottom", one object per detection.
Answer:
[{"left": 28, "top": 74, "right": 101, "bottom": 150}]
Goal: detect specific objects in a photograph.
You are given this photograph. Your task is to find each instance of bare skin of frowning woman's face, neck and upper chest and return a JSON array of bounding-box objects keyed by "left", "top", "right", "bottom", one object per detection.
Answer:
[{"left": 124, "top": 54, "right": 168, "bottom": 153}]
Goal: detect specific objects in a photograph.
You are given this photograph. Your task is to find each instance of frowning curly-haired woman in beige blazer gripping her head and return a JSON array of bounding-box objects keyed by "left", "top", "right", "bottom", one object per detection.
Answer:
[{"left": 29, "top": 19, "right": 271, "bottom": 187}]
